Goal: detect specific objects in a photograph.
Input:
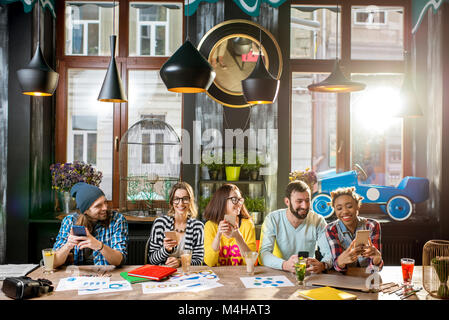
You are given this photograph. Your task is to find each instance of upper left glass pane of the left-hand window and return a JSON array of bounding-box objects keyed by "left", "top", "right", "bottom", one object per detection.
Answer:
[{"left": 65, "top": 1, "right": 119, "bottom": 56}]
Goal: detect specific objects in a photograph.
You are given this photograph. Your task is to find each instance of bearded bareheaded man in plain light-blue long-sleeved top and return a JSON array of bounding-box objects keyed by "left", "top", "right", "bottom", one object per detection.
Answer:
[{"left": 259, "top": 180, "right": 332, "bottom": 273}]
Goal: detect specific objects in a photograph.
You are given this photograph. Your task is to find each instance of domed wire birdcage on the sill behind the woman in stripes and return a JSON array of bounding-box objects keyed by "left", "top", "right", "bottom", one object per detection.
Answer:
[{"left": 119, "top": 118, "right": 181, "bottom": 216}]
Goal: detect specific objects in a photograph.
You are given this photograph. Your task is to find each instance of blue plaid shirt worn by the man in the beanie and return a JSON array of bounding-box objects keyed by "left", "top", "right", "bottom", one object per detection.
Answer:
[{"left": 53, "top": 211, "right": 128, "bottom": 265}]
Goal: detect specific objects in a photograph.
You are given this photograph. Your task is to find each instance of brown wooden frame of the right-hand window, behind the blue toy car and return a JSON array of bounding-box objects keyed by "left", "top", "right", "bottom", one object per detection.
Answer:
[{"left": 288, "top": 0, "right": 412, "bottom": 212}]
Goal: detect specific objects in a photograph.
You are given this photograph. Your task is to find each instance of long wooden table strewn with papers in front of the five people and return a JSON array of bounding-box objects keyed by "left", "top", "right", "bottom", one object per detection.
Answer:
[{"left": 0, "top": 266, "right": 433, "bottom": 300}]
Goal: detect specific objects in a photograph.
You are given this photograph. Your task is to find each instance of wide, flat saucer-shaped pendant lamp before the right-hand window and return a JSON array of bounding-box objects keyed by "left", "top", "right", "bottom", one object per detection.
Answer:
[{"left": 307, "top": 5, "right": 366, "bottom": 93}]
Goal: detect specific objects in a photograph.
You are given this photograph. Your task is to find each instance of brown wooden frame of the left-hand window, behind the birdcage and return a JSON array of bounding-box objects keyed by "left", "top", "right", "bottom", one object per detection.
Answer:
[{"left": 55, "top": 0, "right": 186, "bottom": 209}]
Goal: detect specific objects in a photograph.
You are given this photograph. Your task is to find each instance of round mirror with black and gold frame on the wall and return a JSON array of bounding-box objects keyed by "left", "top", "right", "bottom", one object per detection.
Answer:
[{"left": 198, "top": 20, "right": 282, "bottom": 108}]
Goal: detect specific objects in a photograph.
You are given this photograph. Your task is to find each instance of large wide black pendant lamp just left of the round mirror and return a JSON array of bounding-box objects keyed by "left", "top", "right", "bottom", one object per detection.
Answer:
[{"left": 159, "top": 1, "right": 216, "bottom": 93}]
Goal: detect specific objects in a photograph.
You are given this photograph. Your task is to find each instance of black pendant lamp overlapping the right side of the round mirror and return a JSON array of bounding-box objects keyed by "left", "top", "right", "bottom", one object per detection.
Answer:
[{"left": 242, "top": 30, "right": 280, "bottom": 104}]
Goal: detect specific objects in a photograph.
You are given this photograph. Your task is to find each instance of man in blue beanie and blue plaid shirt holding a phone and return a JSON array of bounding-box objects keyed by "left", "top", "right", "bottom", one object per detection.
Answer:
[{"left": 53, "top": 182, "right": 128, "bottom": 268}]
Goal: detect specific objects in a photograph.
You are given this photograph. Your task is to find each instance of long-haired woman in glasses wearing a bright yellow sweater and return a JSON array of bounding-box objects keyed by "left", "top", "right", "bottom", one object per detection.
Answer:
[{"left": 204, "top": 183, "right": 256, "bottom": 267}]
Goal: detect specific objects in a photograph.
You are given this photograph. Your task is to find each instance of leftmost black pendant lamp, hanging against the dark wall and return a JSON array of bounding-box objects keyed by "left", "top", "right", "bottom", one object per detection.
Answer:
[{"left": 17, "top": 1, "right": 59, "bottom": 96}]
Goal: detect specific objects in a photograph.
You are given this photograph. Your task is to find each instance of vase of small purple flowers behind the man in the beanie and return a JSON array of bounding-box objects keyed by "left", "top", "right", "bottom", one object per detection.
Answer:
[{"left": 50, "top": 161, "right": 103, "bottom": 213}]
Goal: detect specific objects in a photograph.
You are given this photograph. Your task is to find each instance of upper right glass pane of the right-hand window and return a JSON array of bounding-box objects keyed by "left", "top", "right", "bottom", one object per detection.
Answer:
[{"left": 351, "top": 6, "right": 404, "bottom": 60}]
